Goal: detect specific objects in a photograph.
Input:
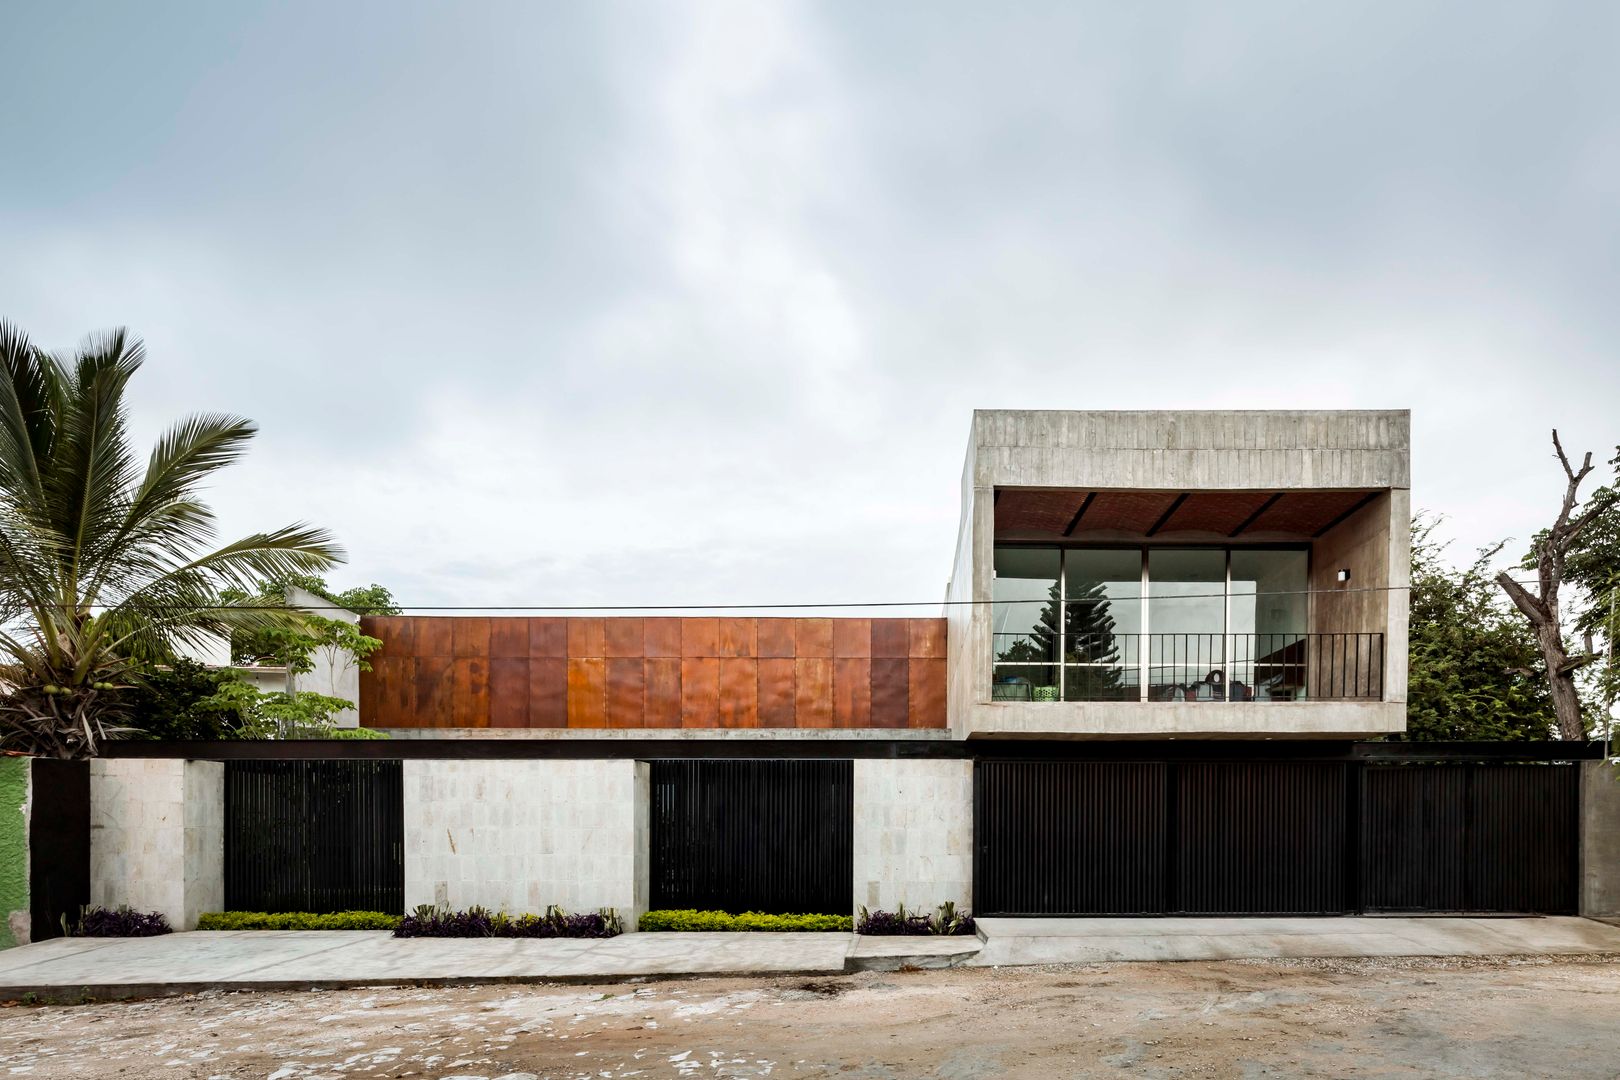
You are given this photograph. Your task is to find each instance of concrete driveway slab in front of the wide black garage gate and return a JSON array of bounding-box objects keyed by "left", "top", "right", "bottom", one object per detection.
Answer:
[{"left": 966, "top": 916, "right": 1620, "bottom": 967}]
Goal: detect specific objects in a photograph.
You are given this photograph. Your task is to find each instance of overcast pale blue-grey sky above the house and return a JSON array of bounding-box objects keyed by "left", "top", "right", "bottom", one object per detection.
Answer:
[{"left": 0, "top": 0, "right": 1620, "bottom": 606}]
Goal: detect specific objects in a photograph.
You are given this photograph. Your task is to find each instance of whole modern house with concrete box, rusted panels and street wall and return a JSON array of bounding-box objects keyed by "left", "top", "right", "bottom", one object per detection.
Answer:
[{"left": 92, "top": 411, "right": 1620, "bottom": 920}]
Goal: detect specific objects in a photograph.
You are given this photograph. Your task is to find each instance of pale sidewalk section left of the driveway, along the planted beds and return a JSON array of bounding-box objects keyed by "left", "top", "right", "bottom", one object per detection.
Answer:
[{"left": 0, "top": 931, "right": 980, "bottom": 999}]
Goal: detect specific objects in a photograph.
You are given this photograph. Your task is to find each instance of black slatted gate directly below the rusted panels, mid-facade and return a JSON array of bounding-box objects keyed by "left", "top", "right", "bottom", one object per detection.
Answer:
[{"left": 650, "top": 759, "right": 854, "bottom": 915}]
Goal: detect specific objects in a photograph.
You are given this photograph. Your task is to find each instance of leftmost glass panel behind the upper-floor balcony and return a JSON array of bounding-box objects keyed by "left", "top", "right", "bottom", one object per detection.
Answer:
[{"left": 990, "top": 547, "right": 1063, "bottom": 701}]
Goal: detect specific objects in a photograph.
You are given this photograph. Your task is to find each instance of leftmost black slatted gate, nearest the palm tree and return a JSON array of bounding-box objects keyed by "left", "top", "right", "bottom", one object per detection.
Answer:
[{"left": 225, "top": 761, "right": 405, "bottom": 913}]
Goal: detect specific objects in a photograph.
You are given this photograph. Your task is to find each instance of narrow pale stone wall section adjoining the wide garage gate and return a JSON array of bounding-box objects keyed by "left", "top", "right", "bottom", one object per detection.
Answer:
[{"left": 854, "top": 758, "right": 974, "bottom": 912}]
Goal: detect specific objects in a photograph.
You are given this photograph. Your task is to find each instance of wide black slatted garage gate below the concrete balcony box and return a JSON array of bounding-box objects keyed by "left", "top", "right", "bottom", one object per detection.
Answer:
[{"left": 974, "top": 761, "right": 1580, "bottom": 915}]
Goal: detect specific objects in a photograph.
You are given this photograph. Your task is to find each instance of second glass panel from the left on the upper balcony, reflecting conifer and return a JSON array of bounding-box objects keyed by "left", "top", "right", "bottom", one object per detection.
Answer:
[{"left": 1063, "top": 547, "right": 1142, "bottom": 701}]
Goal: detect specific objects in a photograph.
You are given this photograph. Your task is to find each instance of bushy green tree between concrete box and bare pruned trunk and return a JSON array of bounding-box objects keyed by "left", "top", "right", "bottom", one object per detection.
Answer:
[{"left": 1406, "top": 515, "right": 1557, "bottom": 742}]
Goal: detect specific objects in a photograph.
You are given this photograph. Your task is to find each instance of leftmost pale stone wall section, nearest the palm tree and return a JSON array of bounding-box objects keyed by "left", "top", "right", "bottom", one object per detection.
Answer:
[{"left": 91, "top": 758, "right": 225, "bottom": 929}]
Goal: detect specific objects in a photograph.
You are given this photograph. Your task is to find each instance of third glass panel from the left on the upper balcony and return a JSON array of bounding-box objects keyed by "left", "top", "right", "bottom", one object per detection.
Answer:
[{"left": 1147, "top": 547, "right": 1226, "bottom": 701}]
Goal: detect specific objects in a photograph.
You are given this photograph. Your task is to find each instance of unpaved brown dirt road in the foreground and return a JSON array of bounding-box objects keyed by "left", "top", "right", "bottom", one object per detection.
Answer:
[{"left": 0, "top": 957, "right": 1620, "bottom": 1080}]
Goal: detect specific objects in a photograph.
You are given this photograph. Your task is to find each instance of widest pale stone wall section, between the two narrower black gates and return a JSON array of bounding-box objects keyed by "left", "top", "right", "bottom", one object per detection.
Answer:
[{"left": 403, "top": 761, "right": 648, "bottom": 929}]
